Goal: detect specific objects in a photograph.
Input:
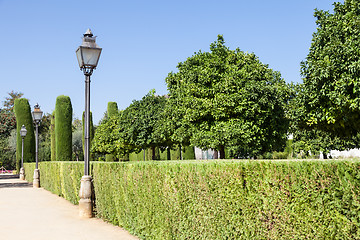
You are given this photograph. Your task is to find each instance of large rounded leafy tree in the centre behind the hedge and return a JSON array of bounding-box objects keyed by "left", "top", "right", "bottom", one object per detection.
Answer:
[{"left": 166, "top": 35, "right": 289, "bottom": 158}]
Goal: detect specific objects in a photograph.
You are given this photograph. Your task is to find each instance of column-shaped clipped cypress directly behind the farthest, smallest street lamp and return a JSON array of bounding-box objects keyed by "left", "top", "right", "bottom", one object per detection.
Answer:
[{"left": 14, "top": 98, "right": 35, "bottom": 171}]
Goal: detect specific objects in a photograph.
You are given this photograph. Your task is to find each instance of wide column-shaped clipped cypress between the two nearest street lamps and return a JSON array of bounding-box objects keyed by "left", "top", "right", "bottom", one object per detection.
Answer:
[{"left": 55, "top": 95, "right": 72, "bottom": 161}]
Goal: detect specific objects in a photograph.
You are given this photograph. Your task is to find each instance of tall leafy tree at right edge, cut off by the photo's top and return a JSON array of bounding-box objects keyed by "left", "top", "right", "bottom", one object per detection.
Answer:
[{"left": 298, "top": 0, "right": 360, "bottom": 139}]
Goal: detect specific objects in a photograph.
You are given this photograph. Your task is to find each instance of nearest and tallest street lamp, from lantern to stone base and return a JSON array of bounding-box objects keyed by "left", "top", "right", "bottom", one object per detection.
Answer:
[{"left": 76, "top": 29, "right": 102, "bottom": 218}]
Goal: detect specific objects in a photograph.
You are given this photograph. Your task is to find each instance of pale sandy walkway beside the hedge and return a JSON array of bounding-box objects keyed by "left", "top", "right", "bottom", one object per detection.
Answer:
[{"left": 0, "top": 175, "right": 137, "bottom": 240}]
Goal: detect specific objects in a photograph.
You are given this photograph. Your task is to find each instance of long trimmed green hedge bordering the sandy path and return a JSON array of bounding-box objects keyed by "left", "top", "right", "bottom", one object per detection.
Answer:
[{"left": 26, "top": 160, "right": 360, "bottom": 239}]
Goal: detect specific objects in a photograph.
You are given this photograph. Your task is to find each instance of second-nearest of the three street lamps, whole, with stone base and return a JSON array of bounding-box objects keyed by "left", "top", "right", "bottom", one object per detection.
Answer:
[{"left": 32, "top": 104, "right": 43, "bottom": 188}]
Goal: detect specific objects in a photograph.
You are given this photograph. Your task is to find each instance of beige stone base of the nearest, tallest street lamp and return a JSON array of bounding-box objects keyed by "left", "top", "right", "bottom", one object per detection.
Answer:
[{"left": 79, "top": 175, "right": 93, "bottom": 218}]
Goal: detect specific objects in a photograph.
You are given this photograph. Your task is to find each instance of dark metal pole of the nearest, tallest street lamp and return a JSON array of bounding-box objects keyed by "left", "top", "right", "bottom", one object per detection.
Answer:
[{"left": 84, "top": 73, "right": 91, "bottom": 176}]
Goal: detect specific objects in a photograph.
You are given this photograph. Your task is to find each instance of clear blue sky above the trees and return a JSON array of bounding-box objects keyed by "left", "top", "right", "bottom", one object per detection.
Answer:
[{"left": 0, "top": 0, "right": 343, "bottom": 124}]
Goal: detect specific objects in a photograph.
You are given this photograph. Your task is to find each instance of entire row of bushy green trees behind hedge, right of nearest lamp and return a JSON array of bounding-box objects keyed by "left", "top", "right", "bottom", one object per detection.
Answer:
[{"left": 93, "top": 0, "right": 360, "bottom": 158}]
